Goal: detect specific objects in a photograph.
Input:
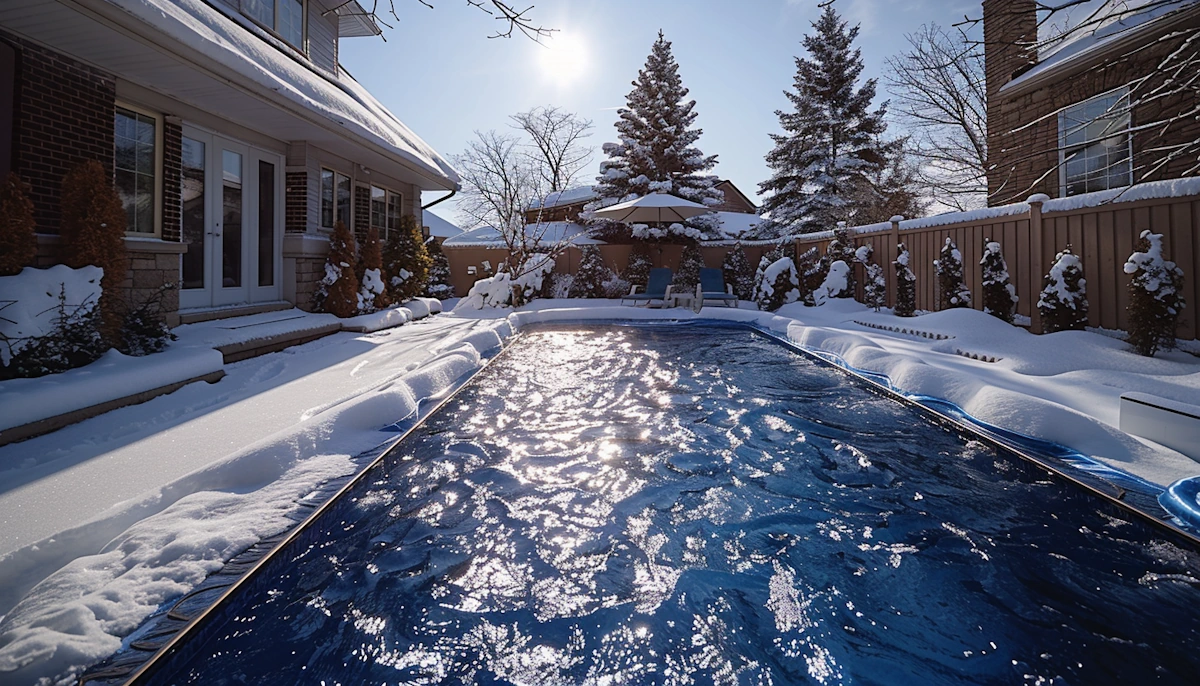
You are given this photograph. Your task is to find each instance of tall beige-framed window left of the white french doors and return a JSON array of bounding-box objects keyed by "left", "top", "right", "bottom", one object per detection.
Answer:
[{"left": 113, "top": 107, "right": 162, "bottom": 234}]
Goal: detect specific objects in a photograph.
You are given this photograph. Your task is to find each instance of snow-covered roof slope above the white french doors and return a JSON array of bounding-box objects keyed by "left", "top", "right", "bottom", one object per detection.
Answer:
[{"left": 108, "top": 0, "right": 458, "bottom": 185}]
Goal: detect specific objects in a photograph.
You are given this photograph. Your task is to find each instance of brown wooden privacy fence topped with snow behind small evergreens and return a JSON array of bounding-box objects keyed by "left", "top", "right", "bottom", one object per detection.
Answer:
[{"left": 444, "top": 182, "right": 1200, "bottom": 339}]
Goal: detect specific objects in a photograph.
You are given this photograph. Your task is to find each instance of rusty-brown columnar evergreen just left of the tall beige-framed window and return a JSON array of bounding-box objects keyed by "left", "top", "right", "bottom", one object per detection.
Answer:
[{"left": 61, "top": 160, "right": 128, "bottom": 345}]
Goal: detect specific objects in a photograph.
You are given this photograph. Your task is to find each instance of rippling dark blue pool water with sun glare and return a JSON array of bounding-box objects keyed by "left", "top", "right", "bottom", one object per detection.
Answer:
[{"left": 138, "top": 327, "right": 1200, "bottom": 685}]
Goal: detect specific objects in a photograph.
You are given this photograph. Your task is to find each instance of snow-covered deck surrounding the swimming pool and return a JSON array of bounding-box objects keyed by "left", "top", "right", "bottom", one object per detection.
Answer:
[{"left": 0, "top": 301, "right": 1200, "bottom": 682}]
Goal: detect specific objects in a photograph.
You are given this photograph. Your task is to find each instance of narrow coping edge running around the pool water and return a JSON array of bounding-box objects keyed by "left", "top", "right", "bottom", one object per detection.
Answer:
[{"left": 112, "top": 318, "right": 1200, "bottom": 686}]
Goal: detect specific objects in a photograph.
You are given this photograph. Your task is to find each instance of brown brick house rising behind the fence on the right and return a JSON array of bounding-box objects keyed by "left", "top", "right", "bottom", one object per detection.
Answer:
[{"left": 983, "top": 0, "right": 1200, "bottom": 205}]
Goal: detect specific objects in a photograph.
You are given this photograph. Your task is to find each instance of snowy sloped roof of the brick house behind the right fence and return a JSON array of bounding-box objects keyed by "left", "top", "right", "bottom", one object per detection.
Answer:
[{"left": 1001, "top": 0, "right": 1200, "bottom": 92}]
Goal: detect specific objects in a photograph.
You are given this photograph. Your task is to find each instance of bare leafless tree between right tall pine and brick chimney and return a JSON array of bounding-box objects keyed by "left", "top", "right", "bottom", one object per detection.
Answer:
[{"left": 887, "top": 24, "right": 988, "bottom": 211}]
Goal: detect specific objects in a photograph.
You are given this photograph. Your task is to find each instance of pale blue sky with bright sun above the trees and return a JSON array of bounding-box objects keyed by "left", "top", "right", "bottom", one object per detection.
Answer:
[{"left": 341, "top": 0, "right": 980, "bottom": 219}]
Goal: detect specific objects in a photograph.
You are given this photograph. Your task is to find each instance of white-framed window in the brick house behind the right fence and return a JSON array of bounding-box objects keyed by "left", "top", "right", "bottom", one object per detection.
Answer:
[{"left": 1058, "top": 89, "right": 1133, "bottom": 197}]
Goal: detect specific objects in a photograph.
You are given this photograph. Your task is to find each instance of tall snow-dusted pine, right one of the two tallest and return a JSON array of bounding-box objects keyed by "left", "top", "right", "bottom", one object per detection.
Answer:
[{"left": 760, "top": 4, "right": 888, "bottom": 233}]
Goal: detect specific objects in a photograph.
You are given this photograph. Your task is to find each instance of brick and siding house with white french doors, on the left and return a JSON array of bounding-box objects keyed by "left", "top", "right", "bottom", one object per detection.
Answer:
[{"left": 0, "top": 0, "right": 458, "bottom": 321}]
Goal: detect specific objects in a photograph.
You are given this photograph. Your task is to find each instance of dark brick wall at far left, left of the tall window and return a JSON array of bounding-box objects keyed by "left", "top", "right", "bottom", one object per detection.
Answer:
[{"left": 0, "top": 32, "right": 116, "bottom": 234}]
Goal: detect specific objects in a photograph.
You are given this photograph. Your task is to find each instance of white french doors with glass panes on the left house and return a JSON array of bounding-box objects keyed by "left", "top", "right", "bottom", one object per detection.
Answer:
[{"left": 179, "top": 127, "right": 283, "bottom": 308}]
